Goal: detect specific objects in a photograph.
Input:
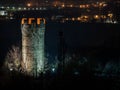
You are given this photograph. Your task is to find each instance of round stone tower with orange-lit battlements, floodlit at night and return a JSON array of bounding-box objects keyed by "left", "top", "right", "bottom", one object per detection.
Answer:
[{"left": 21, "top": 18, "right": 45, "bottom": 76}]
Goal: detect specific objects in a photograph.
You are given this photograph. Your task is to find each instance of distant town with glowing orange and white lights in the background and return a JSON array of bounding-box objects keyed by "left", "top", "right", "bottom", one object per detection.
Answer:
[{"left": 0, "top": 0, "right": 120, "bottom": 24}]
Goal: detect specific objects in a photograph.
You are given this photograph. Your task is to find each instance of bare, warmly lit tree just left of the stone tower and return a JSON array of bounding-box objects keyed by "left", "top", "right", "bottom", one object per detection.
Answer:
[{"left": 5, "top": 46, "right": 22, "bottom": 71}]
